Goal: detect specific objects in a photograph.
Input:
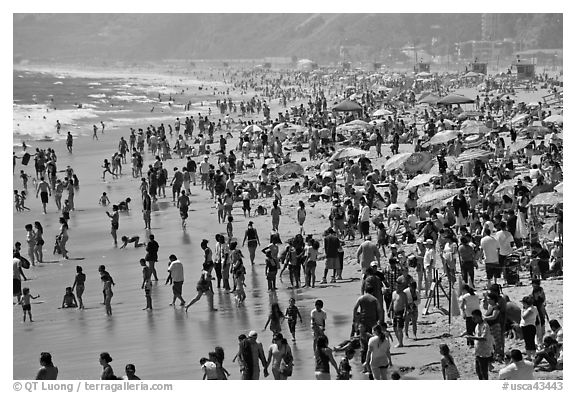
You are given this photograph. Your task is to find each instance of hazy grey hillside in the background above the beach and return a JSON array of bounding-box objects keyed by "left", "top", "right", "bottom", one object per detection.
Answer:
[{"left": 14, "top": 14, "right": 563, "bottom": 61}]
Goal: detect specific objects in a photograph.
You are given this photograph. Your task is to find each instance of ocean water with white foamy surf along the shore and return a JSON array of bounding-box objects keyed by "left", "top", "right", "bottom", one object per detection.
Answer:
[{"left": 13, "top": 69, "right": 216, "bottom": 146}]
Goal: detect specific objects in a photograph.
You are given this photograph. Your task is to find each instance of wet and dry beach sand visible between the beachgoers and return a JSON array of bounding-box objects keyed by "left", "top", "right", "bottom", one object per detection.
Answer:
[{"left": 13, "top": 68, "right": 563, "bottom": 380}]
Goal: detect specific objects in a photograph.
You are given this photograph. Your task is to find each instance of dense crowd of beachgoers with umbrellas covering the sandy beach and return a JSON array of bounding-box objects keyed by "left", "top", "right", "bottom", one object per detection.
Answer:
[{"left": 13, "top": 64, "right": 564, "bottom": 380}]
